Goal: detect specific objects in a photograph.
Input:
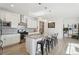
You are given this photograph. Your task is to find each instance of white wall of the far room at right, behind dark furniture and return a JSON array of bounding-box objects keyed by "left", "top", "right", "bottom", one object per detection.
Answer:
[{"left": 63, "top": 17, "right": 79, "bottom": 37}]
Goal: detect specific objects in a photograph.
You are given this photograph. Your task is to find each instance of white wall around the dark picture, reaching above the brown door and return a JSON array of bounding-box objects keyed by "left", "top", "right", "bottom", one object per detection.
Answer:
[{"left": 38, "top": 18, "right": 63, "bottom": 39}]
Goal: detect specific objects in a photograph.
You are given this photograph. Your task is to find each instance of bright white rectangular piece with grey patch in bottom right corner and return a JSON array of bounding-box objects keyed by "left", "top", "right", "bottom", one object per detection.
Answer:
[{"left": 66, "top": 43, "right": 79, "bottom": 55}]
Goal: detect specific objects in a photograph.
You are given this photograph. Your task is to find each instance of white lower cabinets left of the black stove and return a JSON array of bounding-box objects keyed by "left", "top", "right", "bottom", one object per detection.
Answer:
[{"left": 1, "top": 34, "right": 20, "bottom": 47}]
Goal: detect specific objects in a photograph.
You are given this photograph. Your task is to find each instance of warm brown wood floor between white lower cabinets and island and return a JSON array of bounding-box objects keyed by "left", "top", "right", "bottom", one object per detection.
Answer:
[{"left": 3, "top": 43, "right": 27, "bottom": 55}]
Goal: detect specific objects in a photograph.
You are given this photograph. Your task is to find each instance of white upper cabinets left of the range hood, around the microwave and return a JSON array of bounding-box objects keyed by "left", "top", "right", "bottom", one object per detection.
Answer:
[{"left": 0, "top": 10, "right": 20, "bottom": 28}]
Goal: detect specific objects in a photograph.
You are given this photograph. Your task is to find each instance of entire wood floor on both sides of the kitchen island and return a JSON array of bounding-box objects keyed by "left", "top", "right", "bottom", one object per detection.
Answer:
[{"left": 0, "top": 38, "right": 79, "bottom": 55}]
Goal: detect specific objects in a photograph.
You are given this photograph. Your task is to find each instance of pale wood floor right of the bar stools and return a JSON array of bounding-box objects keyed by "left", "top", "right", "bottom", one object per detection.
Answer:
[{"left": 49, "top": 38, "right": 79, "bottom": 55}]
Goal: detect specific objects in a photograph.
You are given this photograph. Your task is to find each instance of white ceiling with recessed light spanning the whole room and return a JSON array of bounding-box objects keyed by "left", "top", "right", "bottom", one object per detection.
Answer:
[{"left": 0, "top": 3, "right": 79, "bottom": 18}]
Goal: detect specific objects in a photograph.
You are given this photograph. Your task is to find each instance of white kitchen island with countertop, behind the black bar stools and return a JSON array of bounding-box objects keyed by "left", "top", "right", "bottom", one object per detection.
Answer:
[{"left": 26, "top": 35, "right": 43, "bottom": 55}]
